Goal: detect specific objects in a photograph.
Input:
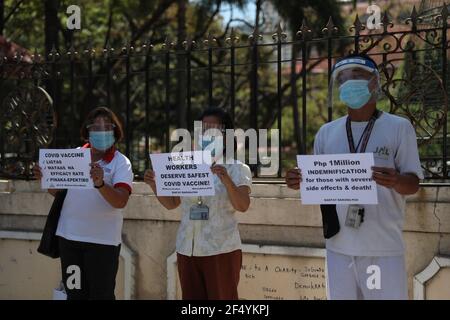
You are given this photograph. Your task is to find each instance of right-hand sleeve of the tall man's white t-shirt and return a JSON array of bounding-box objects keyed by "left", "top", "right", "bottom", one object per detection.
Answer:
[{"left": 394, "top": 120, "right": 424, "bottom": 179}]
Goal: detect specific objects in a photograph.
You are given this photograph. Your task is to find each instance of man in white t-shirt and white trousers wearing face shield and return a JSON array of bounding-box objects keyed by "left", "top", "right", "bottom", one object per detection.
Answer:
[{"left": 286, "top": 55, "right": 423, "bottom": 299}]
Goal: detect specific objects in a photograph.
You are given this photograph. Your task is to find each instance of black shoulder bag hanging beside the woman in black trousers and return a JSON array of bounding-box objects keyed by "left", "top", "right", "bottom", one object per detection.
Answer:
[{"left": 37, "top": 189, "right": 67, "bottom": 258}]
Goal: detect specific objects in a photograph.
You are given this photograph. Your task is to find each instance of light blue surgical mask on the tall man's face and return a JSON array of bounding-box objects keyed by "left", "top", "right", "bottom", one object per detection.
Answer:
[{"left": 339, "top": 80, "right": 372, "bottom": 109}]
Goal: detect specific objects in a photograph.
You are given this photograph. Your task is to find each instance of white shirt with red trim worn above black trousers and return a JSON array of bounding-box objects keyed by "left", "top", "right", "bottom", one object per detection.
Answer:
[{"left": 56, "top": 151, "right": 133, "bottom": 246}]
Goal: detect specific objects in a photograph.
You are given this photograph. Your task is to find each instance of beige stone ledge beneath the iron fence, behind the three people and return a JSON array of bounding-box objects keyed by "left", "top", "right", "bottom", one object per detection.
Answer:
[{"left": 0, "top": 192, "right": 450, "bottom": 233}]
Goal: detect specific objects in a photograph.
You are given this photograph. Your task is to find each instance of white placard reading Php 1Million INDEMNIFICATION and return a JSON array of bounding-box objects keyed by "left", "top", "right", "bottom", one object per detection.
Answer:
[{"left": 297, "top": 153, "right": 378, "bottom": 204}]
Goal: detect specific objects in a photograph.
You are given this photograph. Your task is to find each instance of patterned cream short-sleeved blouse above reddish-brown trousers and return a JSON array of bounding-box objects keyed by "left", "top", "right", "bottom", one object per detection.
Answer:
[{"left": 176, "top": 161, "right": 252, "bottom": 256}]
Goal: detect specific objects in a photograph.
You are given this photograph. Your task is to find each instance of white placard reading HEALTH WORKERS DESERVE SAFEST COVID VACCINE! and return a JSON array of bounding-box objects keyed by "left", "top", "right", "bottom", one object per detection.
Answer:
[{"left": 150, "top": 151, "right": 215, "bottom": 197}]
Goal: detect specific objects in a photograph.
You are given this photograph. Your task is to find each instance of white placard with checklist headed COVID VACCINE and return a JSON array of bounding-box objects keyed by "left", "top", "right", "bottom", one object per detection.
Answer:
[{"left": 39, "top": 149, "right": 94, "bottom": 189}]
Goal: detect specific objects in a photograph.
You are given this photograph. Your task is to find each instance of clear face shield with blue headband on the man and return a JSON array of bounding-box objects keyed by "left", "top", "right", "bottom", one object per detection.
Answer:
[{"left": 328, "top": 64, "right": 381, "bottom": 110}]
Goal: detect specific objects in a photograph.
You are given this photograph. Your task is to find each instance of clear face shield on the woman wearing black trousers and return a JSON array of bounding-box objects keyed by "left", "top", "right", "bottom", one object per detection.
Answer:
[{"left": 86, "top": 117, "right": 115, "bottom": 152}]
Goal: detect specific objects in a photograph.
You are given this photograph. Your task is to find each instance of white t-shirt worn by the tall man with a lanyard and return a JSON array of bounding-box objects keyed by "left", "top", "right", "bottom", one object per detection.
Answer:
[{"left": 314, "top": 112, "right": 423, "bottom": 256}]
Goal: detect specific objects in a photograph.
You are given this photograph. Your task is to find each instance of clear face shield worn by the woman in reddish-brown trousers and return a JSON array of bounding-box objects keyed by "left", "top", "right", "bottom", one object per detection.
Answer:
[{"left": 195, "top": 122, "right": 225, "bottom": 162}]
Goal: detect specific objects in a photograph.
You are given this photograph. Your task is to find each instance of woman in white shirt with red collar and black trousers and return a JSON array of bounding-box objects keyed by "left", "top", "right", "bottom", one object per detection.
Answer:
[{"left": 33, "top": 107, "right": 133, "bottom": 300}]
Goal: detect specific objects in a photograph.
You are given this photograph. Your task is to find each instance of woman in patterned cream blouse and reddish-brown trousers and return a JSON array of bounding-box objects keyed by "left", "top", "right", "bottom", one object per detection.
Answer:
[{"left": 144, "top": 108, "right": 252, "bottom": 300}]
